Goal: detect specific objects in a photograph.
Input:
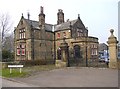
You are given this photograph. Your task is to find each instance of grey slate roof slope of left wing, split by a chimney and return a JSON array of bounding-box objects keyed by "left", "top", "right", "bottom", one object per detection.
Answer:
[{"left": 25, "top": 19, "right": 53, "bottom": 31}]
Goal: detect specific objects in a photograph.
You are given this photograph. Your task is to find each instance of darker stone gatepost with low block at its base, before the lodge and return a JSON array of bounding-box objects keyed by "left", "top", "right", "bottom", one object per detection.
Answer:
[{"left": 56, "top": 38, "right": 69, "bottom": 67}]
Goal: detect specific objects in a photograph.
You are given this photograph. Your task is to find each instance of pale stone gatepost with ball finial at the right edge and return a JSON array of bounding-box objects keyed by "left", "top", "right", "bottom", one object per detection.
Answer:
[{"left": 107, "top": 29, "right": 118, "bottom": 68}]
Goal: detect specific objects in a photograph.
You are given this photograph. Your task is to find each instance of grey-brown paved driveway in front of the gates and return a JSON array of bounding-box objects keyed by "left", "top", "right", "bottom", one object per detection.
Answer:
[{"left": 6, "top": 67, "right": 118, "bottom": 87}]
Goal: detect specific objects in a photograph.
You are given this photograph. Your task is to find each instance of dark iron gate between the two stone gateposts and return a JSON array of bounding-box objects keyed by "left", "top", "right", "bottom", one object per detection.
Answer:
[{"left": 69, "top": 45, "right": 107, "bottom": 68}]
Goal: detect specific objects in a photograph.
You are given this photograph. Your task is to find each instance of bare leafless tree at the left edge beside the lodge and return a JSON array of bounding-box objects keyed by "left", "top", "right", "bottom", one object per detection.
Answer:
[{"left": 0, "top": 13, "right": 13, "bottom": 61}]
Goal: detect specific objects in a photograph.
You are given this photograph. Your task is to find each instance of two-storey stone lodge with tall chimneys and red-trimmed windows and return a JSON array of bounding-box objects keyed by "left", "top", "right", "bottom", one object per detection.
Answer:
[{"left": 14, "top": 7, "right": 98, "bottom": 61}]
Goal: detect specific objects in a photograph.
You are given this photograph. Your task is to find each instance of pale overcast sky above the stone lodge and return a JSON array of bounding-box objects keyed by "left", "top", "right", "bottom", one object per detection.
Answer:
[{"left": 0, "top": 0, "right": 119, "bottom": 43}]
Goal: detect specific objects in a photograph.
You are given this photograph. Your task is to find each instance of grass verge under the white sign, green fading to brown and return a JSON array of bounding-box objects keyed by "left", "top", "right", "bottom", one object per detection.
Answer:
[{"left": 0, "top": 65, "right": 56, "bottom": 78}]
